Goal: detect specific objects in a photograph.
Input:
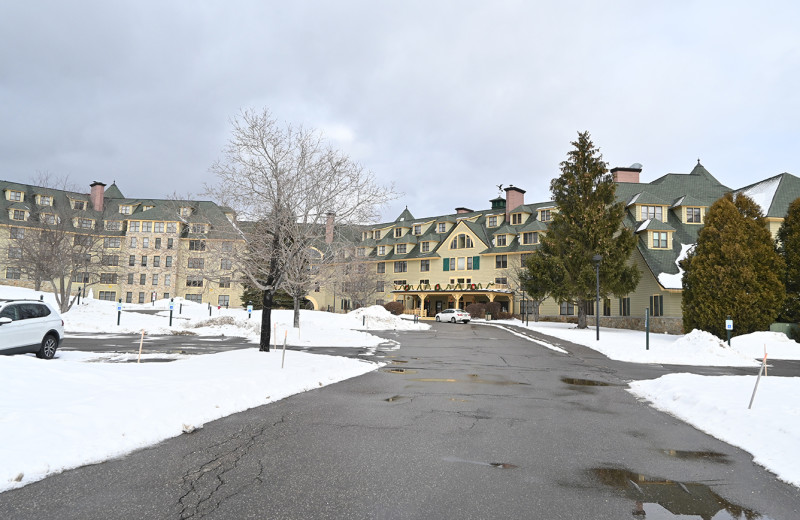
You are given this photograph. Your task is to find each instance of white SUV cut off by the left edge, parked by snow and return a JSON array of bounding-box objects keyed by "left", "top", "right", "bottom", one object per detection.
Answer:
[{"left": 0, "top": 300, "right": 64, "bottom": 359}]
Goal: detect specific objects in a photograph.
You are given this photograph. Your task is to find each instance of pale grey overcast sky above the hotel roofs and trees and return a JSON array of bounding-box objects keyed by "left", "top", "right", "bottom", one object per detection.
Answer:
[{"left": 0, "top": 0, "right": 800, "bottom": 220}]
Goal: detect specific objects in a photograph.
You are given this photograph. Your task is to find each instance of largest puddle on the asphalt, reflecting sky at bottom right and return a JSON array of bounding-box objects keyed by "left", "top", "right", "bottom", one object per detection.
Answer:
[{"left": 591, "top": 468, "right": 770, "bottom": 520}]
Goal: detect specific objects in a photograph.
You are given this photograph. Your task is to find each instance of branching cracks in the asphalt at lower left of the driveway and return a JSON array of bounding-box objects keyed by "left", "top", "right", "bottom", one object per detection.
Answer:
[{"left": 177, "top": 417, "right": 286, "bottom": 520}]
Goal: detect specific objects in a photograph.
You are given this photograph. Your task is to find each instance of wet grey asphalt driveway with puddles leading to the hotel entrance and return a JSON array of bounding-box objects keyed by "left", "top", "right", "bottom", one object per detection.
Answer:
[{"left": 0, "top": 324, "right": 800, "bottom": 520}]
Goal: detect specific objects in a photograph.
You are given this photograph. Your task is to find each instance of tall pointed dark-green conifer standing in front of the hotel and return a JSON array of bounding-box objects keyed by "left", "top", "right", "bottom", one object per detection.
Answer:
[{"left": 531, "top": 132, "right": 639, "bottom": 328}]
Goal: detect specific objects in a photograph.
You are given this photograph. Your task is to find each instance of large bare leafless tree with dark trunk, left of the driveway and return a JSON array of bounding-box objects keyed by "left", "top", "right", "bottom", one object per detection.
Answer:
[{"left": 206, "top": 109, "right": 394, "bottom": 351}]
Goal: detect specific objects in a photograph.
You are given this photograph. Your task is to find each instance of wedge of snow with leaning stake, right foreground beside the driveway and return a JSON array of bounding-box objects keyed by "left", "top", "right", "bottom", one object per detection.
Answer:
[{"left": 630, "top": 374, "right": 800, "bottom": 486}]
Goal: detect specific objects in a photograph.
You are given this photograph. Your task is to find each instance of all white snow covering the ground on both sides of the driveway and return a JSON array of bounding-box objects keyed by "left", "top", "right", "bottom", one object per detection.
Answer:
[{"left": 0, "top": 286, "right": 800, "bottom": 491}]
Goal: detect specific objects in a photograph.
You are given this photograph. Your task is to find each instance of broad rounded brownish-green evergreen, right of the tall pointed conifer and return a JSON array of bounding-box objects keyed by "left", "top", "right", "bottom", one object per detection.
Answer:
[{"left": 681, "top": 193, "right": 785, "bottom": 338}]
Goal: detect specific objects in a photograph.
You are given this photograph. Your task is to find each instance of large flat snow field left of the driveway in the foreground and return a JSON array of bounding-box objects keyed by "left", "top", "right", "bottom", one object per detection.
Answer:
[{"left": 0, "top": 349, "right": 380, "bottom": 491}]
